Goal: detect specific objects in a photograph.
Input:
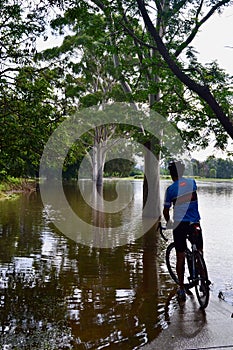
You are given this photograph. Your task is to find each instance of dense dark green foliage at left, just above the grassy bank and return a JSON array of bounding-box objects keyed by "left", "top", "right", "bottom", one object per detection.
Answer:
[{"left": 0, "top": 66, "right": 64, "bottom": 176}]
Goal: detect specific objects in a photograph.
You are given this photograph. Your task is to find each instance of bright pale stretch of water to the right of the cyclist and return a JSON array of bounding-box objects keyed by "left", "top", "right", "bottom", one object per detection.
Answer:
[{"left": 199, "top": 181, "right": 233, "bottom": 304}]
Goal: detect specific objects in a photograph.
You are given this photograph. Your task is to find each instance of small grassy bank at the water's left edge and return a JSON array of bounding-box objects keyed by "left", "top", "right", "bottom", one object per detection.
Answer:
[{"left": 0, "top": 177, "right": 37, "bottom": 199}]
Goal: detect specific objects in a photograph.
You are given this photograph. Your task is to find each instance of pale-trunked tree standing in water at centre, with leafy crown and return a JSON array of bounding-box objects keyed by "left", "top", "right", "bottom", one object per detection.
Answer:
[{"left": 37, "top": 5, "right": 147, "bottom": 186}]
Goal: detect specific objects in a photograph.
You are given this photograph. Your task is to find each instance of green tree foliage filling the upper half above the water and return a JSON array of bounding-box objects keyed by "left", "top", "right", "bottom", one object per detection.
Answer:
[{"left": 0, "top": 0, "right": 232, "bottom": 177}]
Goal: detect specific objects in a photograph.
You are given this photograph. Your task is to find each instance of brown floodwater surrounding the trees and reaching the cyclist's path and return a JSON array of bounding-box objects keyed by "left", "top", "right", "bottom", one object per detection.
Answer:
[{"left": 0, "top": 181, "right": 233, "bottom": 350}]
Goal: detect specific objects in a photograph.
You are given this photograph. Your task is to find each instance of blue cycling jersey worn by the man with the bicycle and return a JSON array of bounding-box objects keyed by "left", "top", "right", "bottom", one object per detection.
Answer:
[{"left": 164, "top": 177, "right": 200, "bottom": 222}]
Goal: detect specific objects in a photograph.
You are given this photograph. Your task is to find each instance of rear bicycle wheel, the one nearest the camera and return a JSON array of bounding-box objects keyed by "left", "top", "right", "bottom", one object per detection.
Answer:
[{"left": 195, "top": 252, "right": 210, "bottom": 309}]
